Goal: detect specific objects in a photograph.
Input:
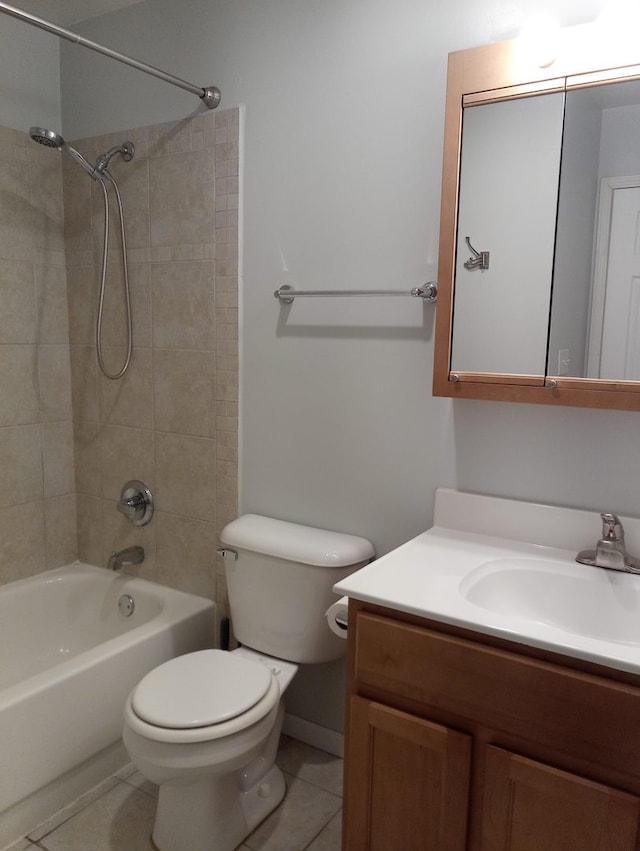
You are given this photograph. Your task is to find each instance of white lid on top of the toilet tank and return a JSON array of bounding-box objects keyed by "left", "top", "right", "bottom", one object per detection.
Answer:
[{"left": 220, "top": 514, "right": 375, "bottom": 567}]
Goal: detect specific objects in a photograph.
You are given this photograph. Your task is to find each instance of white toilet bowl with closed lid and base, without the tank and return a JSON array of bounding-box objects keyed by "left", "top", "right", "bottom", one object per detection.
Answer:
[{"left": 123, "top": 648, "right": 297, "bottom": 851}]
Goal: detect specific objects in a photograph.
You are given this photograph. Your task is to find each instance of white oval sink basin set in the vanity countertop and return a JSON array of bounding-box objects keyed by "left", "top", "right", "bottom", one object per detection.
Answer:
[{"left": 459, "top": 557, "right": 640, "bottom": 644}]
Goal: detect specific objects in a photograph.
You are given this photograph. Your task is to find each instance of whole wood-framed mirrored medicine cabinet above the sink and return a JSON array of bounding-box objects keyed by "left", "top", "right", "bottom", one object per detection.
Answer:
[{"left": 433, "top": 25, "right": 640, "bottom": 410}]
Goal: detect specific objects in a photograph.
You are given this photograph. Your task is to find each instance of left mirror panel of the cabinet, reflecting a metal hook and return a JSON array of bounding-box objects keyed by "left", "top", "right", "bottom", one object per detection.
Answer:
[{"left": 451, "top": 92, "right": 564, "bottom": 376}]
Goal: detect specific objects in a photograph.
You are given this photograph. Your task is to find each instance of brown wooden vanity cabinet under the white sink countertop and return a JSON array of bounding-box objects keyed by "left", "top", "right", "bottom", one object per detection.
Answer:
[{"left": 343, "top": 600, "right": 640, "bottom": 851}]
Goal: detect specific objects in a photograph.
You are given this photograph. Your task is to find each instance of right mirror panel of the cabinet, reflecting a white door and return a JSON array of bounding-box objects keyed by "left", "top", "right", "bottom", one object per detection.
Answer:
[{"left": 547, "top": 80, "right": 640, "bottom": 381}]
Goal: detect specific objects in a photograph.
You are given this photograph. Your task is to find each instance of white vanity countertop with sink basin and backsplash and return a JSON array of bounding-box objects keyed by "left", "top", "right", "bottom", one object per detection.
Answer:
[{"left": 334, "top": 490, "right": 640, "bottom": 674}]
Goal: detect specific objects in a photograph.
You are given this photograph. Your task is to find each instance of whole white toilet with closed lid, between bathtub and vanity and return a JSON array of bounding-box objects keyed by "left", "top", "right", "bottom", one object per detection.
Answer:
[{"left": 123, "top": 514, "right": 374, "bottom": 851}]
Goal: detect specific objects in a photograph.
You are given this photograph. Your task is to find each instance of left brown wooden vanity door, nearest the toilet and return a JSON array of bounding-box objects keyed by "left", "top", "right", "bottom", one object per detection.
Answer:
[{"left": 343, "top": 697, "right": 471, "bottom": 851}]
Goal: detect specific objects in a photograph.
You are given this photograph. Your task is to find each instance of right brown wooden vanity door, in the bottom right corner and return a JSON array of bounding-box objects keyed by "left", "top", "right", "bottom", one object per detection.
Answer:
[{"left": 481, "top": 747, "right": 640, "bottom": 851}]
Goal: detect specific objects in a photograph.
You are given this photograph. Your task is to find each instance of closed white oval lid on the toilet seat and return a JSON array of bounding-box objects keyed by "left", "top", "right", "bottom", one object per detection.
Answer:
[{"left": 131, "top": 650, "right": 273, "bottom": 729}]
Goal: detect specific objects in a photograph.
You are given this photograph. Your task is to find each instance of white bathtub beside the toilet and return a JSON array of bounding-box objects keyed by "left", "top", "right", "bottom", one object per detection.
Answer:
[{"left": 0, "top": 563, "right": 215, "bottom": 848}]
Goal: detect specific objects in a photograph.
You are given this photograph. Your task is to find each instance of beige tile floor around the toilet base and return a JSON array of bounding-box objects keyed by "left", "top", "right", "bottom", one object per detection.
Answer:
[{"left": 7, "top": 736, "right": 342, "bottom": 851}]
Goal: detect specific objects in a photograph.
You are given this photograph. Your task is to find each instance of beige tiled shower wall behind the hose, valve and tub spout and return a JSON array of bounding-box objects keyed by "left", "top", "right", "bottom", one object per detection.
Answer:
[{"left": 63, "top": 109, "right": 239, "bottom": 606}]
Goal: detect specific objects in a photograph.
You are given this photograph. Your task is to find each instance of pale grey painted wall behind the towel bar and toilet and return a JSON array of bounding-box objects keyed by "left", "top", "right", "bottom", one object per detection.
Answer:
[{"left": 16, "top": 0, "right": 640, "bottom": 726}]
